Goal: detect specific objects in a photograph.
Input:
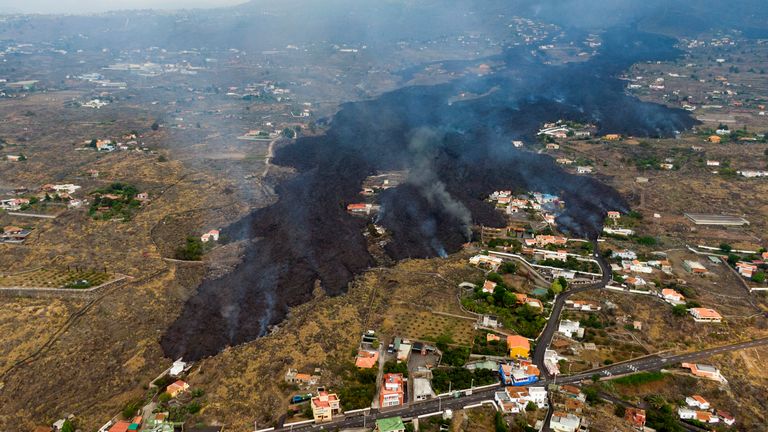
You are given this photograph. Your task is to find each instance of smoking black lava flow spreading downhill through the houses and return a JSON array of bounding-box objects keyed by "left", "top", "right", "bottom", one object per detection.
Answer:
[{"left": 162, "top": 29, "right": 694, "bottom": 360}]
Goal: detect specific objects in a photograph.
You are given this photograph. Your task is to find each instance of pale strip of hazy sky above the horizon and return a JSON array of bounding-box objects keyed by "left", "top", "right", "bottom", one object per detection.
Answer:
[{"left": 0, "top": 0, "right": 247, "bottom": 13}]
